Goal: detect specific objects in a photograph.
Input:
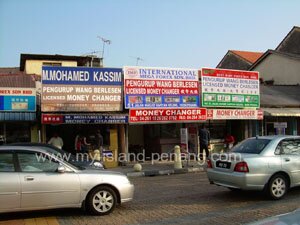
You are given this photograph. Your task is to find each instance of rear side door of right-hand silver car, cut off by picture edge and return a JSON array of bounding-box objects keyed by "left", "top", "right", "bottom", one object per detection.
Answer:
[{"left": 279, "top": 138, "right": 300, "bottom": 185}]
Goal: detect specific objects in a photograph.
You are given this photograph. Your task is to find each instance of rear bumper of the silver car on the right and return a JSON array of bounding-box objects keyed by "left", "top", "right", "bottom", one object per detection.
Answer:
[{"left": 207, "top": 169, "right": 268, "bottom": 190}]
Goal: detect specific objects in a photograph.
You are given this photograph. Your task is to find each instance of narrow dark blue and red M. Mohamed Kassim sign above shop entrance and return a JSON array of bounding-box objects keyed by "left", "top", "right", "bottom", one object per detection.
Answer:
[{"left": 42, "top": 114, "right": 128, "bottom": 124}]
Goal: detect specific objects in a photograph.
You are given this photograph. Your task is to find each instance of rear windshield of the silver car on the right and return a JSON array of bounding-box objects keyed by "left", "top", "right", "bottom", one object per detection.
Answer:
[{"left": 231, "top": 138, "right": 271, "bottom": 154}]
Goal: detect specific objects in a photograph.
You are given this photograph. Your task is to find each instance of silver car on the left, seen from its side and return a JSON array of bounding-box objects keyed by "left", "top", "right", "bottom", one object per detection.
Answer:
[{"left": 0, "top": 145, "right": 134, "bottom": 215}]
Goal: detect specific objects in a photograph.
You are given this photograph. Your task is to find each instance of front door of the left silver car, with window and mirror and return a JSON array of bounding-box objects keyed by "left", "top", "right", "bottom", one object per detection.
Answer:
[{"left": 17, "top": 151, "right": 80, "bottom": 208}]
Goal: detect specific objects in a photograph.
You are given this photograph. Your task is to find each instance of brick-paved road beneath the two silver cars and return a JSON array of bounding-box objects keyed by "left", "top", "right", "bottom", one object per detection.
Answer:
[{"left": 0, "top": 172, "right": 300, "bottom": 225}]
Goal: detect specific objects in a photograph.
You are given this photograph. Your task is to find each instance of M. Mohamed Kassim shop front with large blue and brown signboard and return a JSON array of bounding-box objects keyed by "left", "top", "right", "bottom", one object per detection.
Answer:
[{"left": 41, "top": 66, "right": 123, "bottom": 167}]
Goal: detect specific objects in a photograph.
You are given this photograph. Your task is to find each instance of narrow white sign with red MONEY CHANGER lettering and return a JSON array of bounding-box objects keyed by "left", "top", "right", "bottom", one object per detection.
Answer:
[{"left": 207, "top": 109, "right": 263, "bottom": 120}]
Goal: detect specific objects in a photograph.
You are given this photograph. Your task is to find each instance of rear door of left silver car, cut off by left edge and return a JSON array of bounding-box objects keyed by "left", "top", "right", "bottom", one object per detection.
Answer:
[{"left": 0, "top": 151, "right": 21, "bottom": 211}]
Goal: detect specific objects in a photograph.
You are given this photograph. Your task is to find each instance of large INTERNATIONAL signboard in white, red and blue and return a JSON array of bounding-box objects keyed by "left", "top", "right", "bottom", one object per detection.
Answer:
[{"left": 124, "top": 67, "right": 200, "bottom": 109}]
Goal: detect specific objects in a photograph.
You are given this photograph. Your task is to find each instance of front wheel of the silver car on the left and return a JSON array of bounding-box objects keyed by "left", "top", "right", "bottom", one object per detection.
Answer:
[{"left": 87, "top": 186, "right": 117, "bottom": 216}]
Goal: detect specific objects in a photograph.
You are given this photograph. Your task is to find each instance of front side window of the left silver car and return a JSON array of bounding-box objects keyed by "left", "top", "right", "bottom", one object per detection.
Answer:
[{"left": 18, "top": 152, "right": 59, "bottom": 172}]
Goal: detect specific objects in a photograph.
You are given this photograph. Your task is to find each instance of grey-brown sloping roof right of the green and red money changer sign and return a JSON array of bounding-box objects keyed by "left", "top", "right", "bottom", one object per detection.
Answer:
[{"left": 260, "top": 85, "right": 300, "bottom": 107}]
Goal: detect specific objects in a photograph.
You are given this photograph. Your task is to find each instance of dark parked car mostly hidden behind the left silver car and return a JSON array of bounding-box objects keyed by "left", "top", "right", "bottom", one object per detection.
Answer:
[{"left": 8, "top": 142, "right": 104, "bottom": 169}]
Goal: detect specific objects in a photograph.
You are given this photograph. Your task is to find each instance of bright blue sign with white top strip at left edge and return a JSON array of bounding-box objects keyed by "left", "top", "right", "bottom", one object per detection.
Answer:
[{"left": 0, "top": 87, "right": 36, "bottom": 112}]
